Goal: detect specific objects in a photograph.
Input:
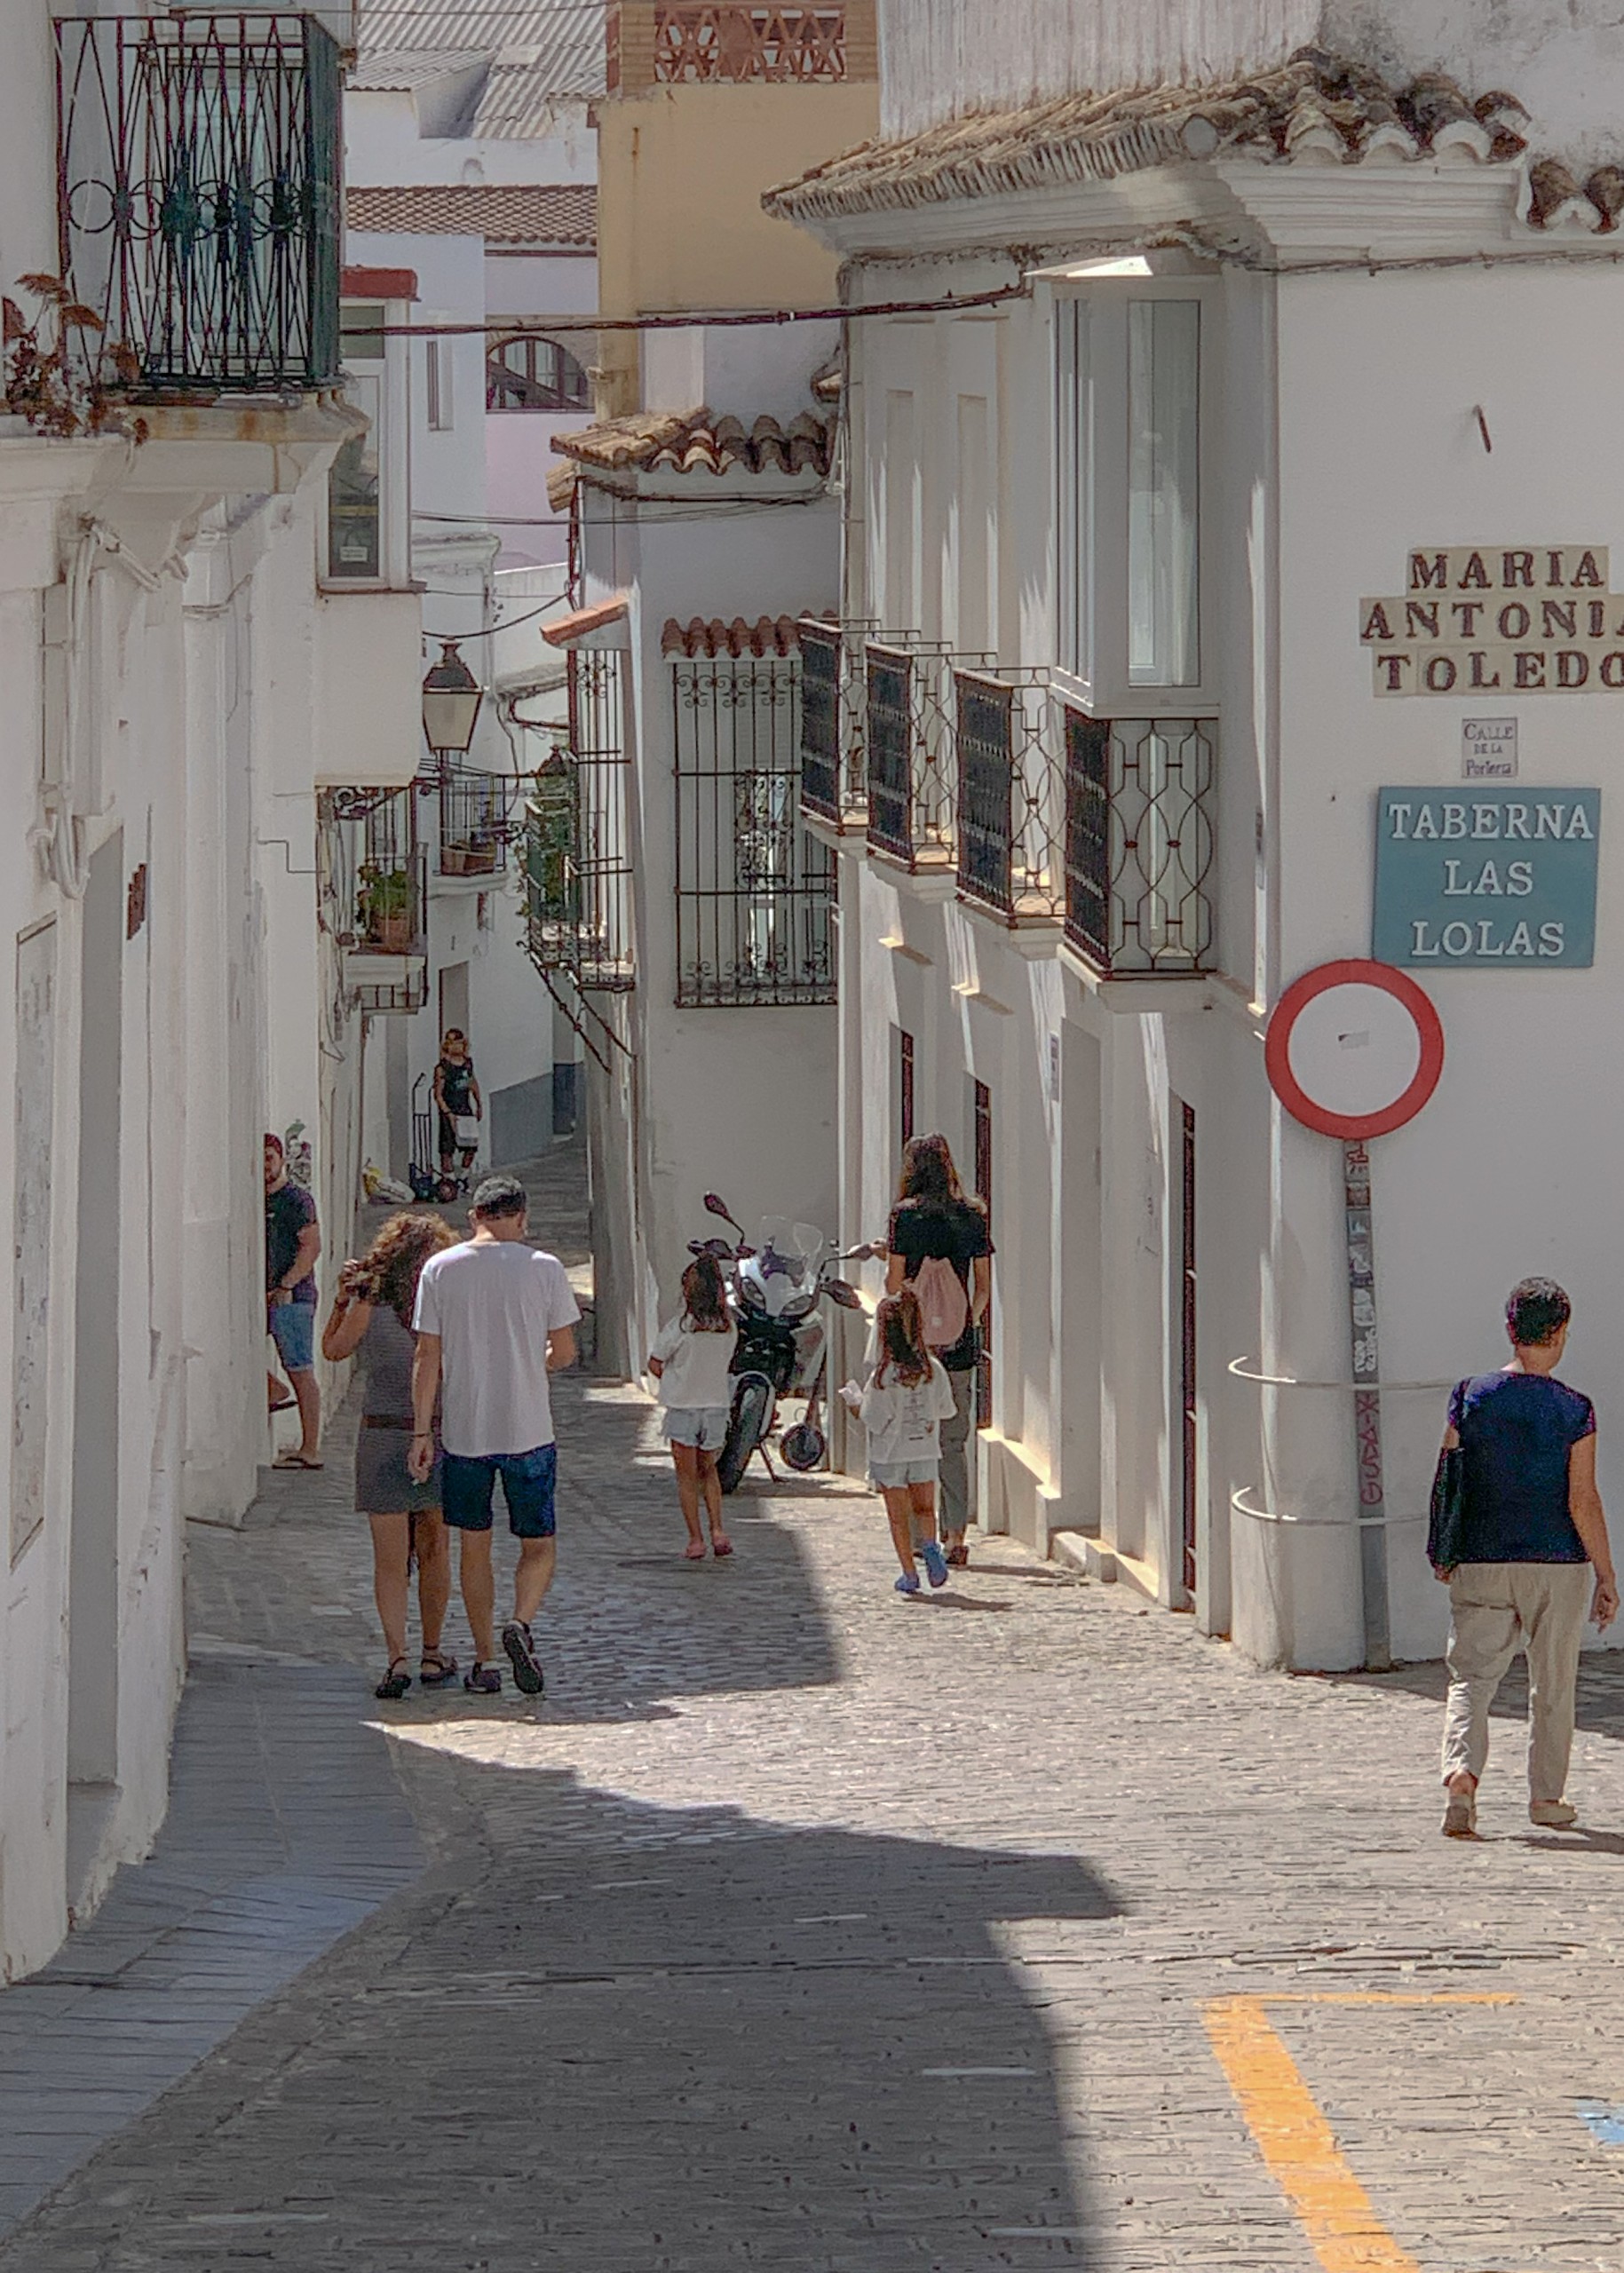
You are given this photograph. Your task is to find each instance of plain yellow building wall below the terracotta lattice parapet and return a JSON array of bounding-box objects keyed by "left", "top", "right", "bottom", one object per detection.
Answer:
[{"left": 596, "top": 82, "right": 880, "bottom": 416}]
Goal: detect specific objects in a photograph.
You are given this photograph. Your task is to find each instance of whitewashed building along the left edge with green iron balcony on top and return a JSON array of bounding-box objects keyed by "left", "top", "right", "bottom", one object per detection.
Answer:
[{"left": 0, "top": 0, "right": 421, "bottom": 1977}]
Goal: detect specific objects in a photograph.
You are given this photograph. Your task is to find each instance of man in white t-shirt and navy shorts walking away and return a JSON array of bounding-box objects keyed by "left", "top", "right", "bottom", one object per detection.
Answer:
[{"left": 409, "top": 1176, "right": 580, "bottom": 1696}]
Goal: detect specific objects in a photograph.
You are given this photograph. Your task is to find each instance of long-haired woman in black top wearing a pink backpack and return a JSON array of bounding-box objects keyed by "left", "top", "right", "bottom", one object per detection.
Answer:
[{"left": 884, "top": 1136, "right": 992, "bottom": 1571}]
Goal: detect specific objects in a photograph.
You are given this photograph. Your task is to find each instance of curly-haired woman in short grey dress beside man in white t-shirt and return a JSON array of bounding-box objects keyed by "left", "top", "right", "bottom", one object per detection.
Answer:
[{"left": 321, "top": 1214, "right": 457, "bottom": 1698}]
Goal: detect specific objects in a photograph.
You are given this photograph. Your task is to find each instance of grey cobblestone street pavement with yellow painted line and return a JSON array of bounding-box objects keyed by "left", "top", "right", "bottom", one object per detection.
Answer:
[{"left": 0, "top": 1163, "right": 1624, "bottom": 2273}]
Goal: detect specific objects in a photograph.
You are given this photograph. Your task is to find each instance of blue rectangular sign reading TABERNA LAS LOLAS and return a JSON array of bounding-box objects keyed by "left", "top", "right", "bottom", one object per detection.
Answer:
[{"left": 1372, "top": 782, "right": 1601, "bottom": 970}]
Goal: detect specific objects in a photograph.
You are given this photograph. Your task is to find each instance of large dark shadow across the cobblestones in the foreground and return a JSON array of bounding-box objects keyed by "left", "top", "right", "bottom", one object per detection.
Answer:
[{"left": 0, "top": 1772, "right": 1114, "bottom": 2273}]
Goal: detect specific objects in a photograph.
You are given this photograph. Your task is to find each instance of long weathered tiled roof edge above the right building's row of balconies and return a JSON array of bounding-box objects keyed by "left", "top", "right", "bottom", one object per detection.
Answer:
[{"left": 762, "top": 48, "right": 1526, "bottom": 220}]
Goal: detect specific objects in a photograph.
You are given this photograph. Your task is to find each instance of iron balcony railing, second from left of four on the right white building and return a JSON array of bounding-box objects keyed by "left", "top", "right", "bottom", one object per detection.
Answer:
[{"left": 864, "top": 634, "right": 992, "bottom": 868}]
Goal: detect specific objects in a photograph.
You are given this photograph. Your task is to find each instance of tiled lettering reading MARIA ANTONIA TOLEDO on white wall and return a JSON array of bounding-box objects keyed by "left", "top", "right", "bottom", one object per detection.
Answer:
[{"left": 1358, "top": 545, "right": 1624, "bottom": 698}]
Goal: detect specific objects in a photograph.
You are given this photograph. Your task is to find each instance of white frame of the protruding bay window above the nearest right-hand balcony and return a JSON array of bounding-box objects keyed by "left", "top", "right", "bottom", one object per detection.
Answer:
[{"left": 1050, "top": 275, "right": 1222, "bottom": 718}]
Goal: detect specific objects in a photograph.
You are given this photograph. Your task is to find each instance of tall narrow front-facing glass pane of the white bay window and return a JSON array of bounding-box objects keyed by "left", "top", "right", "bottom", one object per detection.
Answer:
[{"left": 1129, "top": 300, "right": 1201, "bottom": 686}]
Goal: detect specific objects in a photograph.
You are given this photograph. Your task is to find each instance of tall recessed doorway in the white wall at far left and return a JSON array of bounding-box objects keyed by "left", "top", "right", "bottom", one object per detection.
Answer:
[{"left": 68, "top": 832, "right": 125, "bottom": 1845}]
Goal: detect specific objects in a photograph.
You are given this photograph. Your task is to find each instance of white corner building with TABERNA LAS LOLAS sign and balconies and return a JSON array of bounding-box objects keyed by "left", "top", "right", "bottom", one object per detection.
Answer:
[{"left": 766, "top": 0, "right": 1624, "bottom": 1668}]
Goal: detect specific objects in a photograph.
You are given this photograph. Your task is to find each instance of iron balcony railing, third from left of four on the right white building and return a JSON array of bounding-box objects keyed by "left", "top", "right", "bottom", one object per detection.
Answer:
[{"left": 953, "top": 670, "right": 1066, "bottom": 923}]
